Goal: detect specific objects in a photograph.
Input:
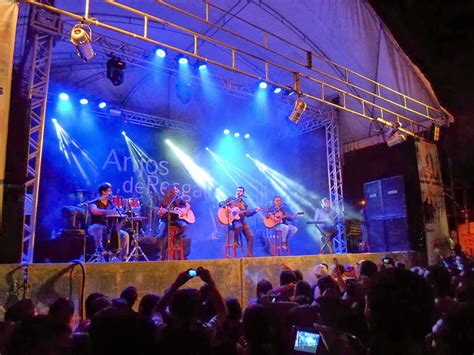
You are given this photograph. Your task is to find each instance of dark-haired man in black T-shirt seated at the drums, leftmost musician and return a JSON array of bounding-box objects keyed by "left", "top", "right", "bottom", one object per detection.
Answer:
[{"left": 88, "top": 182, "right": 130, "bottom": 260}]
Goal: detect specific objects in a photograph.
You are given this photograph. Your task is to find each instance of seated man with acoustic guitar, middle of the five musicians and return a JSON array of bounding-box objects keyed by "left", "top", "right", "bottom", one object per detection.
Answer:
[{"left": 219, "top": 186, "right": 261, "bottom": 257}]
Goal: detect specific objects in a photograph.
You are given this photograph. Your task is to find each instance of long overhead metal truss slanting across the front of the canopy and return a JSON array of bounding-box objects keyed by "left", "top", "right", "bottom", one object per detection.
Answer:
[{"left": 23, "top": 0, "right": 449, "bottom": 139}]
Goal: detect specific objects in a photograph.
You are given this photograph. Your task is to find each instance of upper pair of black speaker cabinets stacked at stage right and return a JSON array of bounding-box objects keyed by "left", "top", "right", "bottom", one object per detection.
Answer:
[{"left": 364, "top": 176, "right": 407, "bottom": 219}]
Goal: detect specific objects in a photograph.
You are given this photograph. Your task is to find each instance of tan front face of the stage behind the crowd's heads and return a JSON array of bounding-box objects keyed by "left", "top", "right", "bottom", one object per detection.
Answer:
[{"left": 0, "top": 252, "right": 425, "bottom": 318}]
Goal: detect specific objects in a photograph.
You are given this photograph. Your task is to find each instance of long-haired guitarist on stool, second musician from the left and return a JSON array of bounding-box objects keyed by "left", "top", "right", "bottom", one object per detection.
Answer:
[{"left": 157, "top": 185, "right": 191, "bottom": 256}]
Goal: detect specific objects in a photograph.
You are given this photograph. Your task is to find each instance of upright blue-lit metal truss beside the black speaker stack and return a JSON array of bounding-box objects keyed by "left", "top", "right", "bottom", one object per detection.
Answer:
[{"left": 325, "top": 114, "right": 347, "bottom": 254}]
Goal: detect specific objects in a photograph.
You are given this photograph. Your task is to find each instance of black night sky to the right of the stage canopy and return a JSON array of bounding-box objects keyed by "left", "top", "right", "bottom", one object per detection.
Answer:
[{"left": 369, "top": 0, "right": 474, "bottom": 211}]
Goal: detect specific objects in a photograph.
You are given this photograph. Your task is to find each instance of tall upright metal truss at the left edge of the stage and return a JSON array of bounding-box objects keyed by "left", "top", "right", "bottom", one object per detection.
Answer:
[{"left": 22, "top": 0, "right": 60, "bottom": 263}]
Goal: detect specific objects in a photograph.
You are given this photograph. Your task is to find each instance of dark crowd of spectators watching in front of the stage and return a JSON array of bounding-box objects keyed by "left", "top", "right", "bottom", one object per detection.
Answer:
[{"left": 0, "top": 252, "right": 474, "bottom": 355}]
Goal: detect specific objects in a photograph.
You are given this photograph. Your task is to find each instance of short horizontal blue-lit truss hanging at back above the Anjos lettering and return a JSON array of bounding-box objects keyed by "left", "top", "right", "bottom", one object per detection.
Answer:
[{"left": 91, "top": 109, "right": 199, "bottom": 135}]
